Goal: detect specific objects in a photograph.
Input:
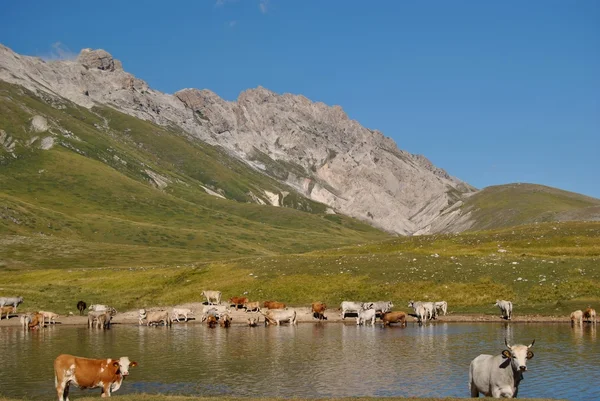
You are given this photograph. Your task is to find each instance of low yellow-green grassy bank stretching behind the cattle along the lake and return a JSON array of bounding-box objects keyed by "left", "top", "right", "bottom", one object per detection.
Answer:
[{"left": 1, "top": 223, "right": 600, "bottom": 315}]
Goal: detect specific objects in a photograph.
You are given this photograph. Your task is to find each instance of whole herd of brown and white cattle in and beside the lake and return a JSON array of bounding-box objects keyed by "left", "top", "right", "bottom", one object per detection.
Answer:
[{"left": 0, "top": 291, "right": 596, "bottom": 401}]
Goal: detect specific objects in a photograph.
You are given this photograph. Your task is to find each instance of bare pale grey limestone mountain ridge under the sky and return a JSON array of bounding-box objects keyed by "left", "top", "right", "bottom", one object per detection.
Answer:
[{"left": 0, "top": 45, "right": 474, "bottom": 234}]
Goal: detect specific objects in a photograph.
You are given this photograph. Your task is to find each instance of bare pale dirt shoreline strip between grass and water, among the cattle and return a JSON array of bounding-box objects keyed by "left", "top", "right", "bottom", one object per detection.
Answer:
[{"left": 0, "top": 303, "right": 571, "bottom": 327}]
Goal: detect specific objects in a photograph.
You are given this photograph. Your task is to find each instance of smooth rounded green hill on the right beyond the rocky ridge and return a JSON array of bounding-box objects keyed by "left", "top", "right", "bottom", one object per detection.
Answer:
[{"left": 454, "top": 184, "right": 600, "bottom": 230}]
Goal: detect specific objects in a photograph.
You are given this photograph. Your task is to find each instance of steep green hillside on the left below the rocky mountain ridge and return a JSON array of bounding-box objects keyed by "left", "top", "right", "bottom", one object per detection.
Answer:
[{"left": 0, "top": 82, "right": 387, "bottom": 269}]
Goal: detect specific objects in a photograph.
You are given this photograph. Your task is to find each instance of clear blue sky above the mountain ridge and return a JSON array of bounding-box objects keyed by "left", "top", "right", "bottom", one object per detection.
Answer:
[{"left": 0, "top": 0, "right": 600, "bottom": 198}]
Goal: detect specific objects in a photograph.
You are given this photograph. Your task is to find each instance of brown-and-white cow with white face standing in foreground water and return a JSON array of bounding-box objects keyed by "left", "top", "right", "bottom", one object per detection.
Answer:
[{"left": 54, "top": 354, "right": 137, "bottom": 401}]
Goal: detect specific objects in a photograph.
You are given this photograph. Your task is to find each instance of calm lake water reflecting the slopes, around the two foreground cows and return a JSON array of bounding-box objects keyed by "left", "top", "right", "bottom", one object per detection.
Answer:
[{"left": 0, "top": 323, "right": 600, "bottom": 401}]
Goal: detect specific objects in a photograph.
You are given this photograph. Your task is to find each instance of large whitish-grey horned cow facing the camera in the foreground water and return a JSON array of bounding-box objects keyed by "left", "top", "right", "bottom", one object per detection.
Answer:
[{"left": 469, "top": 340, "right": 535, "bottom": 398}]
